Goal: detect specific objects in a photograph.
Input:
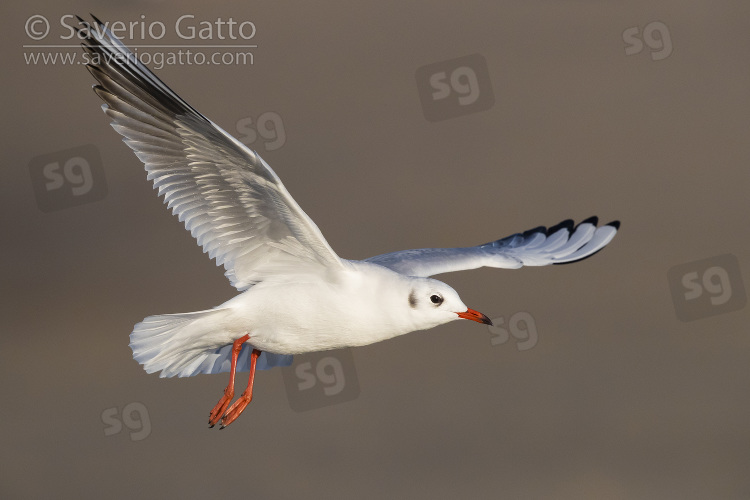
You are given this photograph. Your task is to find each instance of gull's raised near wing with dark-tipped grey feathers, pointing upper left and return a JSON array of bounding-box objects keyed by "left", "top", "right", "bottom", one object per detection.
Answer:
[{"left": 78, "top": 18, "right": 343, "bottom": 290}]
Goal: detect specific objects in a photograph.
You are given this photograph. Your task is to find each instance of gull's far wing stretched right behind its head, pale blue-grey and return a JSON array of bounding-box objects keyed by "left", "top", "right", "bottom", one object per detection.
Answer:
[{"left": 367, "top": 217, "right": 620, "bottom": 277}]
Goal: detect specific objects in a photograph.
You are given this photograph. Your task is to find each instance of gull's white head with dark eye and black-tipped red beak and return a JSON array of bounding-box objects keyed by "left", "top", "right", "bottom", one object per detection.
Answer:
[{"left": 404, "top": 278, "right": 492, "bottom": 328}]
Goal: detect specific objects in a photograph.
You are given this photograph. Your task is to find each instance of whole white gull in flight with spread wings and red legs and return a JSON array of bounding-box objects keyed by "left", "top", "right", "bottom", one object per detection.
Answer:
[{"left": 79, "top": 18, "right": 619, "bottom": 426}]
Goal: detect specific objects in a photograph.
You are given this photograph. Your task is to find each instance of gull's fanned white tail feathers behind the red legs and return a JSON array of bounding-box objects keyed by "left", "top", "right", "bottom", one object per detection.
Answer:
[{"left": 130, "top": 309, "right": 292, "bottom": 377}]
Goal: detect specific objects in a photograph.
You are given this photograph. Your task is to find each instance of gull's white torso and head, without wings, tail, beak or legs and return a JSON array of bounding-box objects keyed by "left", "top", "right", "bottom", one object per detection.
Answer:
[{"left": 217, "top": 262, "right": 468, "bottom": 354}]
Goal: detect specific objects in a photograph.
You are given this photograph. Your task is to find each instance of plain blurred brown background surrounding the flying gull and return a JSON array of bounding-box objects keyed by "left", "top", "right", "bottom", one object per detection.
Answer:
[{"left": 0, "top": 0, "right": 750, "bottom": 499}]
